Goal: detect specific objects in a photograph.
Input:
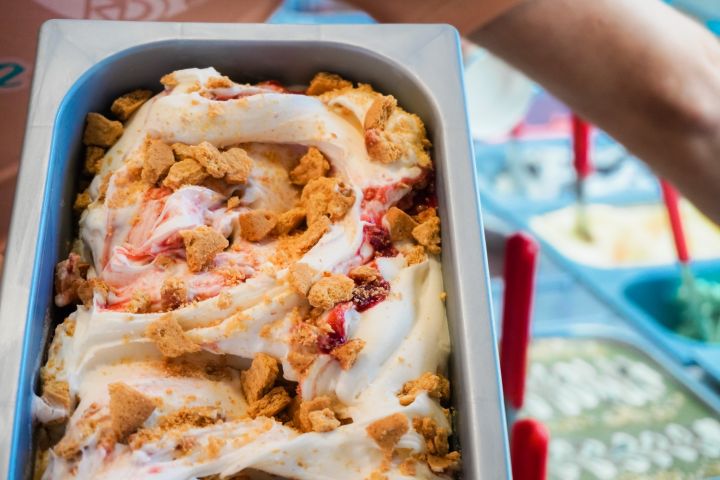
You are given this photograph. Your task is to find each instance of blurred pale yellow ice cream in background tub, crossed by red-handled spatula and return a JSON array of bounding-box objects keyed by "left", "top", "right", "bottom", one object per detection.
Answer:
[{"left": 530, "top": 202, "right": 720, "bottom": 268}]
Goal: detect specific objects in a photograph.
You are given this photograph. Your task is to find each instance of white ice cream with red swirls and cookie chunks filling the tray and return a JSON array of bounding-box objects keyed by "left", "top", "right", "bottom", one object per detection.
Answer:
[{"left": 34, "top": 68, "right": 459, "bottom": 480}]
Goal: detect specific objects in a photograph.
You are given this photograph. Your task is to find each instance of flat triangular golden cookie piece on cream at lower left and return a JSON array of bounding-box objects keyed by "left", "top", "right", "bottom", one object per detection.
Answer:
[{"left": 108, "top": 382, "right": 155, "bottom": 441}]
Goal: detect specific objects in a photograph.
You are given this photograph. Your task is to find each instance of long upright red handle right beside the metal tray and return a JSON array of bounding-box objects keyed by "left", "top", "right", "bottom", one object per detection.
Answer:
[{"left": 500, "top": 233, "right": 538, "bottom": 409}]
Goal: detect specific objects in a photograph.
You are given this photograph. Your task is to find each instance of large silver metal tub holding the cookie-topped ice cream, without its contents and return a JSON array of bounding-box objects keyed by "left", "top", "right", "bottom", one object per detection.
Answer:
[{"left": 0, "top": 20, "right": 510, "bottom": 480}]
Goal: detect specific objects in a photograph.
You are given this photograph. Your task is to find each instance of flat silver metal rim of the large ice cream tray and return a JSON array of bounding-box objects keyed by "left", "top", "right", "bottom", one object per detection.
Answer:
[{"left": 0, "top": 20, "right": 510, "bottom": 479}]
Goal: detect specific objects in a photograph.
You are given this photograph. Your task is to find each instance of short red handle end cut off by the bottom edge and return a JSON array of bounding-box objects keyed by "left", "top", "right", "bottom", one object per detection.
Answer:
[{"left": 510, "top": 418, "right": 550, "bottom": 480}]
